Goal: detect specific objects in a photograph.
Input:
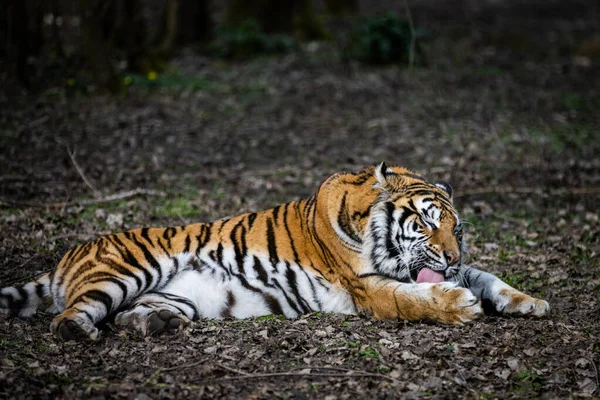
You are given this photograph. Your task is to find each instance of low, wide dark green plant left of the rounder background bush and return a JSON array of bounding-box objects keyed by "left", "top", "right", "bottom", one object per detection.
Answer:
[{"left": 210, "top": 19, "right": 298, "bottom": 59}]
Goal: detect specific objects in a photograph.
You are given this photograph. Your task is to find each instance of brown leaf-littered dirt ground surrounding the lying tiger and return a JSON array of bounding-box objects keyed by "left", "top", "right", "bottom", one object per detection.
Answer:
[{"left": 0, "top": 1, "right": 600, "bottom": 399}]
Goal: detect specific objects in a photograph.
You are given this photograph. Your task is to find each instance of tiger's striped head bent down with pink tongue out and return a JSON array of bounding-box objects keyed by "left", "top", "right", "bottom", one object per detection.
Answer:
[{"left": 363, "top": 163, "right": 464, "bottom": 283}]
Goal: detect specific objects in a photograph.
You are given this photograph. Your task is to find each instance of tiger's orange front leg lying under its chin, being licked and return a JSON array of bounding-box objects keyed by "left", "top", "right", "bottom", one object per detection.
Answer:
[{"left": 354, "top": 275, "right": 483, "bottom": 325}]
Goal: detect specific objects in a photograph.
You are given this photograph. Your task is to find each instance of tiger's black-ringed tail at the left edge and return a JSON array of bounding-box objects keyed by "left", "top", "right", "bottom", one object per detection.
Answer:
[{"left": 0, "top": 273, "right": 58, "bottom": 317}]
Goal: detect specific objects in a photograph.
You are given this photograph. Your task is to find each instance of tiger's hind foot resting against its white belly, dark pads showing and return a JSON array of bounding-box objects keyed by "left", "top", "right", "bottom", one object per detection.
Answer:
[{"left": 115, "top": 292, "right": 198, "bottom": 336}]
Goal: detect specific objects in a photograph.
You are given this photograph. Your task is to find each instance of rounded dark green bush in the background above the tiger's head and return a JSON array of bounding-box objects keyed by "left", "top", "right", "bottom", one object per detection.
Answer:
[{"left": 344, "top": 13, "right": 426, "bottom": 64}]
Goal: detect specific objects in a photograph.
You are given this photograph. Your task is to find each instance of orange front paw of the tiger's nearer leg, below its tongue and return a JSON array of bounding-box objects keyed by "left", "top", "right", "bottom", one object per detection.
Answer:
[{"left": 431, "top": 282, "right": 483, "bottom": 325}]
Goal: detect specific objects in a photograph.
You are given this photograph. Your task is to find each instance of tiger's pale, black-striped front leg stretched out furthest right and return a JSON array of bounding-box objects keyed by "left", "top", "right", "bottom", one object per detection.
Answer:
[{"left": 455, "top": 267, "right": 550, "bottom": 317}]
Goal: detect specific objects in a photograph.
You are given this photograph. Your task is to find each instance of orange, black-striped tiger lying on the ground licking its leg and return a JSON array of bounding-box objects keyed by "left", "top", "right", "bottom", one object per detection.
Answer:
[{"left": 0, "top": 162, "right": 550, "bottom": 340}]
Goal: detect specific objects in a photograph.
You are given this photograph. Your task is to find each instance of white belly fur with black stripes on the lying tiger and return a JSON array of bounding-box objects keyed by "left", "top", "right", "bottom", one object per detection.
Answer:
[{"left": 160, "top": 251, "right": 356, "bottom": 318}]
